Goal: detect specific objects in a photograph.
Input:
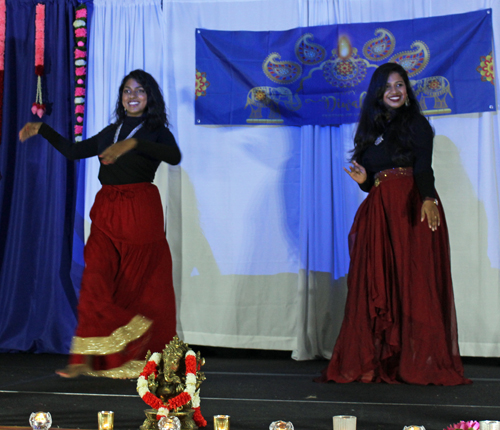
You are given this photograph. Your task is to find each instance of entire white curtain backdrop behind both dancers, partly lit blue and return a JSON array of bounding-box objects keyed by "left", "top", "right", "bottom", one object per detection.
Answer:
[{"left": 87, "top": 0, "right": 500, "bottom": 360}]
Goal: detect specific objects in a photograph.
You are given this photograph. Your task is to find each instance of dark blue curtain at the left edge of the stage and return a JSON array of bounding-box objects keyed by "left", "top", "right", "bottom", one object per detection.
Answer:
[{"left": 0, "top": 0, "right": 78, "bottom": 353}]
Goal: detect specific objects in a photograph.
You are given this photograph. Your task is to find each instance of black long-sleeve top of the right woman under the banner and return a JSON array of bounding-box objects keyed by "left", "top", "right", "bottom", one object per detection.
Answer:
[{"left": 358, "top": 115, "right": 436, "bottom": 199}]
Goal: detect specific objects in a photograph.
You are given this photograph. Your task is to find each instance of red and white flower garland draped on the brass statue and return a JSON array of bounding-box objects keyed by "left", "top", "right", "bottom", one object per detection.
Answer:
[{"left": 137, "top": 350, "right": 207, "bottom": 427}]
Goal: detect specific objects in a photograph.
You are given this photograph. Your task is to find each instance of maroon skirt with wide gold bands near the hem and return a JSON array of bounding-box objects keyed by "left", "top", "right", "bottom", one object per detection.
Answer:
[{"left": 70, "top": 183, "right": 176, "bottom": 378}]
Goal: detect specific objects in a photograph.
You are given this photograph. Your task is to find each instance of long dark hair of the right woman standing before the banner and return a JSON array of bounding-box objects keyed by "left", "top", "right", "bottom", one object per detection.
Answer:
[{"left": 351, "top": 63, "right": 422, "bottom": 164}]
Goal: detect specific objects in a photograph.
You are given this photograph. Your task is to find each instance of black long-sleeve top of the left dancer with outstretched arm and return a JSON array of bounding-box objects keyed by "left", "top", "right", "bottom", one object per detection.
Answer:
[{"left": 38, "top": 117, "right": 181, "bottom": 185}]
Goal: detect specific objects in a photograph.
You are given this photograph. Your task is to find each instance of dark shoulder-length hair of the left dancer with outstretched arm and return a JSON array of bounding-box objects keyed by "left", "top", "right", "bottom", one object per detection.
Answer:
[{"left": 115, "top": 69, "right": 168, "bottom": 130}]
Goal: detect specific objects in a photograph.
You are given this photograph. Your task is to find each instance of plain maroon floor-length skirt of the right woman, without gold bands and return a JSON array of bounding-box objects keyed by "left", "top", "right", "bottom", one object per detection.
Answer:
[{"left": 320, "top": 169, "right": 470, "bottom": 385}]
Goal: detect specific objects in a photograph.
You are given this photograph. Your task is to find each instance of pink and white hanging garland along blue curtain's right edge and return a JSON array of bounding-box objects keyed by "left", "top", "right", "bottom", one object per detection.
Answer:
[{"left": 73, "top": 3, "right": 87, "bottom": 142}]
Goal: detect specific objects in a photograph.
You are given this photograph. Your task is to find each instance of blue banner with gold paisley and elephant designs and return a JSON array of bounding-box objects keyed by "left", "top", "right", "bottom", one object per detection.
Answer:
[{"left": 195, "top": 9, "right": 496, "bottom": 126}]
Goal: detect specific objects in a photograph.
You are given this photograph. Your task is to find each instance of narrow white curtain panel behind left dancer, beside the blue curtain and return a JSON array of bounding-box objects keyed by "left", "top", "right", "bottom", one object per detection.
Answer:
[{"left": 85, "top": 0, "right": 172, "bottom": 232}]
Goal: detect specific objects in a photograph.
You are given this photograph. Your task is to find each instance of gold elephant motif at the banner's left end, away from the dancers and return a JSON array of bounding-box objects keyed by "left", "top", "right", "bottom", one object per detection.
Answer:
[{"left": 245, "top": 87, "right": 302, "bottom": 124}]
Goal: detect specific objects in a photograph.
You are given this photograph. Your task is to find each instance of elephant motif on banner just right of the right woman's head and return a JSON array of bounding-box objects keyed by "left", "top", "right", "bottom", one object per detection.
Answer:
[{"left": 410, "top": 76, "right": 453, "bottom": 114}]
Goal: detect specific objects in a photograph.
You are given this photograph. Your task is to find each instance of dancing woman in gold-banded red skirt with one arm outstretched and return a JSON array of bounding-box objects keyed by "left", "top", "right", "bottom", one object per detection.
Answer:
[{"left": 19, "top": 70, "right": 181, "bottom": 378}]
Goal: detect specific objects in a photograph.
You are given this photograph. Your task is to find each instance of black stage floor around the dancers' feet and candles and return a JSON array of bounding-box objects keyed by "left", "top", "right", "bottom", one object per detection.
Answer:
[{"left": 0, "top": 346, "right": 500, "bottom": 430}]
